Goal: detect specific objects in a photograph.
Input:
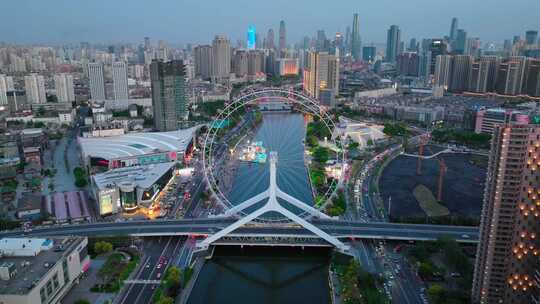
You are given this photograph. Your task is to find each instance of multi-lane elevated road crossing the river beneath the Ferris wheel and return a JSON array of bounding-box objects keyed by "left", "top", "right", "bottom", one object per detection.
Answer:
[{"left": 0, "top": 218, "right": 478, "bottom": 243}]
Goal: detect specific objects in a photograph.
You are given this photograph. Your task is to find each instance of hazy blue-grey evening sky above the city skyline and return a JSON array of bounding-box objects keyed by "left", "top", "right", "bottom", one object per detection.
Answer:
[{"left": 0, "top": 0, "right": 540, "bottom": 44}]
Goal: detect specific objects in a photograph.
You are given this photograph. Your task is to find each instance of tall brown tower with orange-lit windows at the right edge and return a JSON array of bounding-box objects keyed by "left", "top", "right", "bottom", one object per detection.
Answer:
[{"left": 472, "top": 120, "right": 540, "bottom": 304}]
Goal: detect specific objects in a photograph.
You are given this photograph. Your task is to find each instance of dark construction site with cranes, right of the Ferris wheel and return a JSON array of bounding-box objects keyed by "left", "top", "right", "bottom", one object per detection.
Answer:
[{"left": 379, "top": 138, "right": 487, "bottom": 218}]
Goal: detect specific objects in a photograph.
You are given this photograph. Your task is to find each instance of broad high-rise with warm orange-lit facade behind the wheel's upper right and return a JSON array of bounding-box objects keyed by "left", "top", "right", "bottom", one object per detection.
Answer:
[{"left": 303, "top": 51, "right": 339, "bottom": 99}]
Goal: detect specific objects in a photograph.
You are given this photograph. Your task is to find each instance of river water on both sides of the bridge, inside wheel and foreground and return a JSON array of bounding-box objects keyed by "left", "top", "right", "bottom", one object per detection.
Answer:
[{"left": 188, "top": 113, "right": 330, "bottom": 304}]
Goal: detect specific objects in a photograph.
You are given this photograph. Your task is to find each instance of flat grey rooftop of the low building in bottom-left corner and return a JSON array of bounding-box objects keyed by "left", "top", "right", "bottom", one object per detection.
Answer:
[{"left": 0, "top": 237, "right": 84, "bottom": 294}]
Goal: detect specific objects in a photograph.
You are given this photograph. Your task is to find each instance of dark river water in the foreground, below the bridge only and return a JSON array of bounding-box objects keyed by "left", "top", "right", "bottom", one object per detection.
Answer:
[{"left": 188, "top": 247, "right": 330, "bottom": 304}]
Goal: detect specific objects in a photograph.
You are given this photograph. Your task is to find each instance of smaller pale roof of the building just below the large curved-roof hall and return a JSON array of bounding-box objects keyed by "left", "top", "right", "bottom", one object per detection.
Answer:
[{"left": 92, "top": 162, "right": 175, "bottom": 190}]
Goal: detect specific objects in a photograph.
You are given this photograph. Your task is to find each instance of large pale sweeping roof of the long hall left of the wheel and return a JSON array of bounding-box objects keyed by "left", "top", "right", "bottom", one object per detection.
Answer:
[{"left": 78, "top": 126, "right": 200, "bottom": 160}]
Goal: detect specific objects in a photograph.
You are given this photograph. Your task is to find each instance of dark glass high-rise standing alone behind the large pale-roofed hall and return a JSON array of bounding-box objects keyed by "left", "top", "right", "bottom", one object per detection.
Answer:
[{"left": 150, "top": 60, "right": 188, "bottom": 131}]
